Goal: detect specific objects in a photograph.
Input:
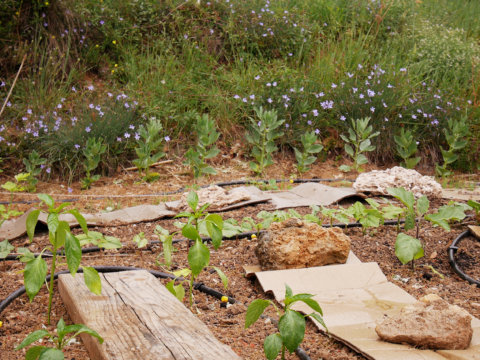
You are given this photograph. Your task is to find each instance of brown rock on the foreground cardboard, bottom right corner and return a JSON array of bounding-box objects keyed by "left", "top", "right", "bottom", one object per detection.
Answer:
[{"left": 375, "top": 294, "right": 473, "bottom": 350}]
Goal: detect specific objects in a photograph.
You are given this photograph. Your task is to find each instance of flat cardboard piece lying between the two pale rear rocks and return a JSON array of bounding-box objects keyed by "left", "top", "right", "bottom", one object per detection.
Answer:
[{"left": 270, "top": 183, "right": 364, "bottom": 209}]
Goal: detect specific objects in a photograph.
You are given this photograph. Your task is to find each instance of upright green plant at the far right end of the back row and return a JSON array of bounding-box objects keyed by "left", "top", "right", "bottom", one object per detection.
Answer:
[{"left": 435, "top": 117, "right": 469, "bottom": 177}]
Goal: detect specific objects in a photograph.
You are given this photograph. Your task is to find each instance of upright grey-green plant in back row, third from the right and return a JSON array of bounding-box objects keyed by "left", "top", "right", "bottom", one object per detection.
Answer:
[{"left": 339, "top": 117, "right": 380, "bottom": 172}]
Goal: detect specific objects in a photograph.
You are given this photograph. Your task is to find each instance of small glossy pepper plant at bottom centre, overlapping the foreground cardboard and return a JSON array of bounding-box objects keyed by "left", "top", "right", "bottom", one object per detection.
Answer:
[{"left": 245, "top": 284, "right": 327, "bottom": 360}]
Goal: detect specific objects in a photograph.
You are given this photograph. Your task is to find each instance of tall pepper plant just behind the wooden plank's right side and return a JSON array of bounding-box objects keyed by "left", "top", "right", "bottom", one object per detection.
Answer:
[{"left": 167, "top": 191, "right": 228, "bottom": 307}]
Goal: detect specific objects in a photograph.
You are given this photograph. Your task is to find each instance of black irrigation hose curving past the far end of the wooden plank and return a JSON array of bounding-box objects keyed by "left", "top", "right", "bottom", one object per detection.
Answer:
[{"left": 0, "top": 266, "right": 311, "bottom": 360}]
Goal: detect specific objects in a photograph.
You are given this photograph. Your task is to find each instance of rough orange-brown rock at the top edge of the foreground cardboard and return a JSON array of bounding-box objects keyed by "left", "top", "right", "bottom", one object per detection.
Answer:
[{"left": 255, "top": 218, "right": 350, "bottom": 270}]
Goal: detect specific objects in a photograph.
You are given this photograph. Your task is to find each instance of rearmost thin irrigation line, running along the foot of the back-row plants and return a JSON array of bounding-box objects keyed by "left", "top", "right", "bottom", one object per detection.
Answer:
[{"left": 0, "top": 179, "right": 355, "bottom": 205}]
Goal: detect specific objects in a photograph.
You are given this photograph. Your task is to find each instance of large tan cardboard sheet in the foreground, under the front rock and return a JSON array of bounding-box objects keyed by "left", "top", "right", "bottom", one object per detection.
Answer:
[{"left": 255, "top": 263, "right": 480, "bottom": 360}]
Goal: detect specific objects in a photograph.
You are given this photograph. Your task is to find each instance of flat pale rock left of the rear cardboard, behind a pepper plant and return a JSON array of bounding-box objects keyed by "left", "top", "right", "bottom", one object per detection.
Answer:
[{"left": 167, "top": 185, "right": 251, "bottom": 211}]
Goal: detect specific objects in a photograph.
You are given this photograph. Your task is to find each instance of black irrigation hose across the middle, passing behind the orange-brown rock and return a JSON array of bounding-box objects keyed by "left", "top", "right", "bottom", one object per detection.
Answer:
[{"left": 0, "top": 219, "right": 405, "bottom": 262}]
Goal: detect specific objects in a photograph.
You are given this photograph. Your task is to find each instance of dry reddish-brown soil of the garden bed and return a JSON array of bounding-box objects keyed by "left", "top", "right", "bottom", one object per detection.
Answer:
[{"left": 0, "top": 158, "right": 480, "bottom": 360}]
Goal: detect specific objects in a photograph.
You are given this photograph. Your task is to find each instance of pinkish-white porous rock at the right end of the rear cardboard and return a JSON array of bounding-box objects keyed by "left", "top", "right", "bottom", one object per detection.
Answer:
[{"left": 353, "top": 166, "right": 442, "bottom": 198}]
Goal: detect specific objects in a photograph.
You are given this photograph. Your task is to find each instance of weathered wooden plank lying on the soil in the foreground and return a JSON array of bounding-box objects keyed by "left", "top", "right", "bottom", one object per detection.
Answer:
[{"left": 58, "top": 270, "right": 240, "bottom": 360}]
